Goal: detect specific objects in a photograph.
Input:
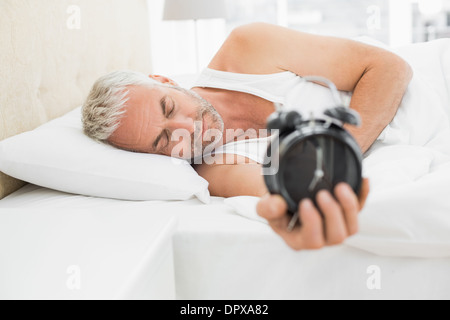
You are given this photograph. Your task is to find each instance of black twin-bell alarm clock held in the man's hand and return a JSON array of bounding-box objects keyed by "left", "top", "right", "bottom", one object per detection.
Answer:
[{"left": 263, "top": 77, "right": 363, "bottom": 229}]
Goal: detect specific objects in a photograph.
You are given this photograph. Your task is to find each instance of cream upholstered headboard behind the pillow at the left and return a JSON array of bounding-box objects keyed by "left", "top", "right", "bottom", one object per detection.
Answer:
[{"left": 0, "top": 0, "right": 151, "bottom": 199}]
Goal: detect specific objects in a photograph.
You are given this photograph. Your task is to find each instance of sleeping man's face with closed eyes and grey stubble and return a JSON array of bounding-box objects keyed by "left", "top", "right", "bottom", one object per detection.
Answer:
[{"left": 109, "top": 85, "right": 224, "bottom": 159}]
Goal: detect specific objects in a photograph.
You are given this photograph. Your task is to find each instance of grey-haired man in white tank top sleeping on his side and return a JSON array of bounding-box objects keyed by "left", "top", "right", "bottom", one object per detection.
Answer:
[{"left": 83, "top": 23, "right": 412, "bottom": 250}]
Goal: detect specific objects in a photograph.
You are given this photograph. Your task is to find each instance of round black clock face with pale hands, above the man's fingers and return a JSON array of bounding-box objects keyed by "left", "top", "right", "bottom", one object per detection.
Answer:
[{"left": 278, "top": 134, "right": 361, "bottom": 208}]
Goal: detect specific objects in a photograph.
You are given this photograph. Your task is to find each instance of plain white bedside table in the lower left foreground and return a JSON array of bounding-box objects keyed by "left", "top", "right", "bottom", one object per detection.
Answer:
[{"left": 0, "top": 206, "right": 176, "bottom": 300}]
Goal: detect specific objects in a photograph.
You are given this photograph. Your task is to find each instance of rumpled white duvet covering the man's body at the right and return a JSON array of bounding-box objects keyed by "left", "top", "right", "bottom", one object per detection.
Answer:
[{"left": 334, "top": 39, "right": 450, "bottom": 257}]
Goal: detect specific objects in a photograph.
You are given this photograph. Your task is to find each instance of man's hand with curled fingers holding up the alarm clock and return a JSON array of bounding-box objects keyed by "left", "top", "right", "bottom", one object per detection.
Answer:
[{"left": 256, "top": 179, "right": 369, "bottom": 250}]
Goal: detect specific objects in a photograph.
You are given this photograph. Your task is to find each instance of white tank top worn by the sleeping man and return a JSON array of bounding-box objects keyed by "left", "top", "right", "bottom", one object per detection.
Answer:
[{"left": 194, "top": 68, "right": 350, "bottom": 163}]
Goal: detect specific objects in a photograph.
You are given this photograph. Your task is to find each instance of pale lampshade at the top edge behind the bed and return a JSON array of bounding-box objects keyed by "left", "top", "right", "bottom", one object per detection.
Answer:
[{"left": 163, "top": 0, "right": 226, "bottom": 20}]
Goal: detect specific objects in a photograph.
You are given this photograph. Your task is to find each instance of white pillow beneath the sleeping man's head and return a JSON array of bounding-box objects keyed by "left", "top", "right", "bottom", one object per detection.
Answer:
[{"left": 0, "top": 107, "right": 210, "bottom": 203}]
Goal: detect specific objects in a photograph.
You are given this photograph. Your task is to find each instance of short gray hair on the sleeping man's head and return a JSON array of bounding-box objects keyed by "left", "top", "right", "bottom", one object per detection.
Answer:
[{"left": 82, "top": 71, "right": 159, "bottom": 143}]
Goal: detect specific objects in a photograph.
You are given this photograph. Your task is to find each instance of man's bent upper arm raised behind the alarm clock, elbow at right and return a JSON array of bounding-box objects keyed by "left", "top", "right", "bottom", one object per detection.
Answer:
[{"left": 210, "top": 23, "right": 412, "bottom": 152}]
